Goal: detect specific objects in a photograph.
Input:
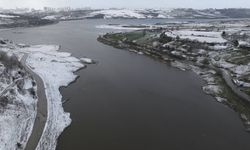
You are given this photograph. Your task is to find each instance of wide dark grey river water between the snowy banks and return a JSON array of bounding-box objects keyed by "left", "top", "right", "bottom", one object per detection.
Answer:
[{"left": 0, "top": 20, "right": 250, "bottom": 150}]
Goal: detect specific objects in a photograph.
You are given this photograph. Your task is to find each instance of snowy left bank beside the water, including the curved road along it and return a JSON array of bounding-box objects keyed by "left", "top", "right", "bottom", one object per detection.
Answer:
[{"left": 0, "top": 42, "right": 85, "bottom": 150}]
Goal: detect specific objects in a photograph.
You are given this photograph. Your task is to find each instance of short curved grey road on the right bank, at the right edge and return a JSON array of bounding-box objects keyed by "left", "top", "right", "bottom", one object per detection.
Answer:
[{"left": 221, "top": 69, "right": 250, "bottom": 102}]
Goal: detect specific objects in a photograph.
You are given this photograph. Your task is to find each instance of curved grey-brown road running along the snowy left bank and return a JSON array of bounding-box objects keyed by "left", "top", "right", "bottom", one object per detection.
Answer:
[{"left": 21, "top": 54, "right": 48, "bottom": 150}]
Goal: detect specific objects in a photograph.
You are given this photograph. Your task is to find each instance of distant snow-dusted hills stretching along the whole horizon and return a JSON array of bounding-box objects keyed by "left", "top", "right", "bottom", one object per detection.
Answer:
[{"left": 0, "top": 8, "right": 250, "bottom": 24}]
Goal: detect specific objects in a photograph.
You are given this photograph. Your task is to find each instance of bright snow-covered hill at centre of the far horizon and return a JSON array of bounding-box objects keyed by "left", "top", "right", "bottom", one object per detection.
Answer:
[{"left": 87, "top": 9, "right": 227, "bottom": 19}]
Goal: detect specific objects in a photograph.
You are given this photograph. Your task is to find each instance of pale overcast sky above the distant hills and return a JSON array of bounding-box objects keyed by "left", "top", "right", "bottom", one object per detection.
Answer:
[{"left": 0, "top": 0, "right": 250, "bottom": 8}]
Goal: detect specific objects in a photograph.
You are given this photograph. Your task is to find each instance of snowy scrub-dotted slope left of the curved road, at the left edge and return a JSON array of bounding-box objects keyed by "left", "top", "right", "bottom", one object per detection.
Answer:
[{"left": 0, "top": 50, "right": 37, "bottom": 150}]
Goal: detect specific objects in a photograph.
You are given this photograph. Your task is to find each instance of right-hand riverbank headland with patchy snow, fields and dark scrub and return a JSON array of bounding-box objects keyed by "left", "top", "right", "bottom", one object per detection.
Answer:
[{"left": 98, "top": 21, "right": 250, "bottom": 130}]
